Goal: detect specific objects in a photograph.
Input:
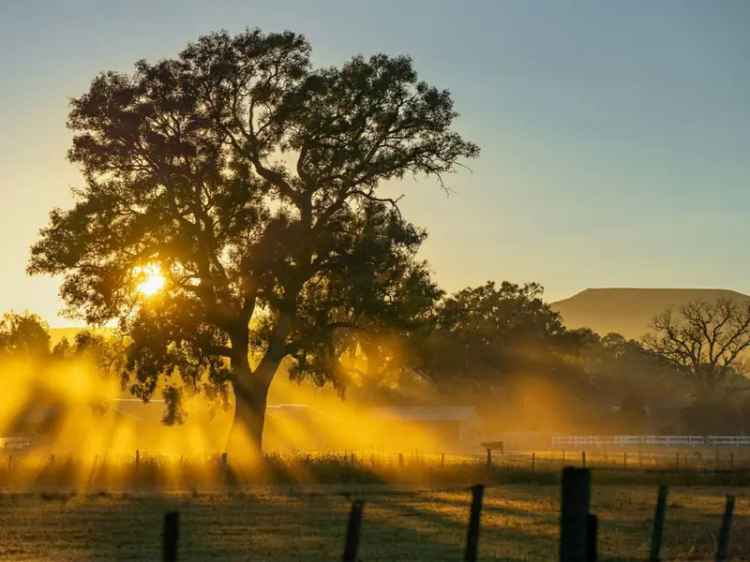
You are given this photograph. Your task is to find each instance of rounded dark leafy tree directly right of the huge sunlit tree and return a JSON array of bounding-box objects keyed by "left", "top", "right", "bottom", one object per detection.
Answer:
[{"left": 420, "top": 281, "right": 612, "bottom": 431}]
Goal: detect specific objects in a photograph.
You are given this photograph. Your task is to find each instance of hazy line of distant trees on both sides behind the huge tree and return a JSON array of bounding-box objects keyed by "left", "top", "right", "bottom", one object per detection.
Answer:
[{"left": 5, "top": 281, "right": 750, "bottom": 434}]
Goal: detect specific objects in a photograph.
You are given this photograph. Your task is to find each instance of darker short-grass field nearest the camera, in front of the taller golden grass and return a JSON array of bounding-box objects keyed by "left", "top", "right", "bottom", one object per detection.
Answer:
[{"left": 0, "top": 478, "right": 750, "bottom": 562}]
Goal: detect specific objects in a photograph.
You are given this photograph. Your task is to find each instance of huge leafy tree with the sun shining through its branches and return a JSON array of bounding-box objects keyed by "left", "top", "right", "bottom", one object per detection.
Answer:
[{"left": 29, "top": 30, "right": 479, "bottom": 452}]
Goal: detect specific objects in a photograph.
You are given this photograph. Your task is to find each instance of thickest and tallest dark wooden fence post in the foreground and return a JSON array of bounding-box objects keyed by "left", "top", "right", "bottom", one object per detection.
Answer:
[{"left": 560, "top": 466, "right": 591, "bottom": 562}]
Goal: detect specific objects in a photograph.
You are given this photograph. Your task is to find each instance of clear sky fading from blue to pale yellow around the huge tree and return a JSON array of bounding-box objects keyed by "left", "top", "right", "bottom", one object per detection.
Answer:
[{"left": 0, "top": 0, "right": 750, "bottom": 326}]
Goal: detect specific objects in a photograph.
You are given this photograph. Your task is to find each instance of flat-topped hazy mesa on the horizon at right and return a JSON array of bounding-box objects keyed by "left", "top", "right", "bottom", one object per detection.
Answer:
[{"left": 551, "top": 288, "right": 750, "bottom": 339}]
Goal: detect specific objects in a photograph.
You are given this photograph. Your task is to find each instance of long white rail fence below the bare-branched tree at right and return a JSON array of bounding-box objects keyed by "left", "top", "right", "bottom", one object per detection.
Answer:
[{"left": 552, "top": 435, "right": 750, "bottom": 449}]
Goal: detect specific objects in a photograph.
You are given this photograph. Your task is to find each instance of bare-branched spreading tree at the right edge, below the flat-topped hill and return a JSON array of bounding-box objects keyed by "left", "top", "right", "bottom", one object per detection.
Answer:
[{"left": 643, "top": 299, "right": 750, "bottom": 401}]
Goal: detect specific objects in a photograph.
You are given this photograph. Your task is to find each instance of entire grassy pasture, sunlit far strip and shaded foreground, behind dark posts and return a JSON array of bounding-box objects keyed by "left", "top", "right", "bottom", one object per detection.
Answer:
[{"left": 0, "top": 452, "right": 750, "bottom": 562}]
